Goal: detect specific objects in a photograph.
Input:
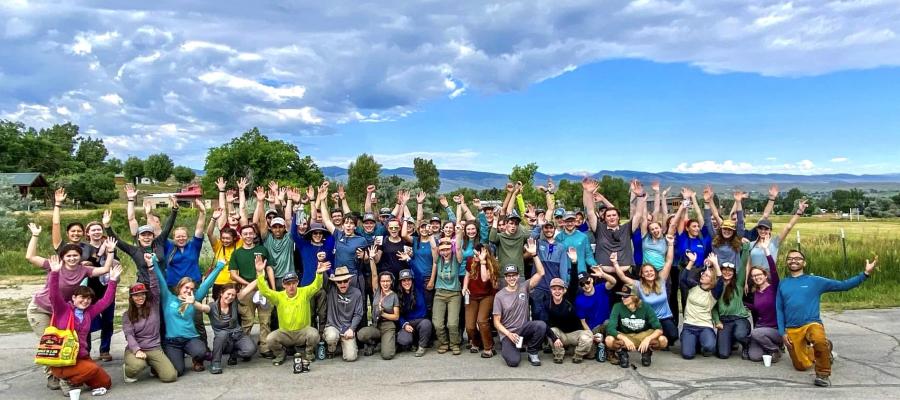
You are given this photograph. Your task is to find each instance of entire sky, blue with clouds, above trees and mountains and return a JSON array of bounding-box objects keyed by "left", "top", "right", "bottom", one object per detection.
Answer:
[{"left": 0, "top": 0, "right": 900, "bottom": 174}]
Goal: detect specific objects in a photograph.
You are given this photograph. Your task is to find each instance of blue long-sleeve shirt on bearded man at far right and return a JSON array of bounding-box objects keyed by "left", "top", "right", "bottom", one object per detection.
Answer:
[{"left": 775, "top": 272, "right": 866, "bottom": 335}]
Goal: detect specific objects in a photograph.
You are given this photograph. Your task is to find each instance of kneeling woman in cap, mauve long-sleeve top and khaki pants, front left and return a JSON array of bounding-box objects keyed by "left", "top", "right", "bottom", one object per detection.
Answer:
[{"left": 122, "top": 253, "right": 178, "bottom": 383}]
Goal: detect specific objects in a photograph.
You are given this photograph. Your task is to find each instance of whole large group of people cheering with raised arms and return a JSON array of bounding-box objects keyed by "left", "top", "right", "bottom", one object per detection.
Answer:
[{"left": 26, "top": 178, "right": 877, "bottom": 394}]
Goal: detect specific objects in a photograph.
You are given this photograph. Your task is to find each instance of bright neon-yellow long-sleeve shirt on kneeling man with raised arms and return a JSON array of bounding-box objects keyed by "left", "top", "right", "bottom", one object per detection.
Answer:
[{"left": 256, "top": 274, "right": 323, "bottom": 331}]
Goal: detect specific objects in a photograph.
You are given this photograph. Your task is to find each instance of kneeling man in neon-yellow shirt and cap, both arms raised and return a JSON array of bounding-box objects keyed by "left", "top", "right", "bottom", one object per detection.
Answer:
[{"left": 254, "top": 255, "right": 331, "bottom": 366}]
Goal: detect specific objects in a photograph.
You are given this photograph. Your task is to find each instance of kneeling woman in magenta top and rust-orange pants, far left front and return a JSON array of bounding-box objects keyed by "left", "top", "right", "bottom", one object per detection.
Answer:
[{"left": 47, "top": 258, "right": 122, "bottom": 396}]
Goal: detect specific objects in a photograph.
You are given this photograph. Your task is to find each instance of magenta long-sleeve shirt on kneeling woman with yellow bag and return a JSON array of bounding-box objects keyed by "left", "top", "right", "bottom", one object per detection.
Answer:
[{"left": 47, "top": 272, "right": 117, "bottom": 359}]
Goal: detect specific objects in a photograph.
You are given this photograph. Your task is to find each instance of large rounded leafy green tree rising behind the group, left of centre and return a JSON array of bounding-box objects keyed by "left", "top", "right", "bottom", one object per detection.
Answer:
[{"left": 202, "top": 128, "right": 325, "bottom": 197}]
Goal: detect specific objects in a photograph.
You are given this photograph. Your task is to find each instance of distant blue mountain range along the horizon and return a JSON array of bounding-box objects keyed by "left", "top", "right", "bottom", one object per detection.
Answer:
[{"left": 322, "top": 167, "right": 900, "bottom": 192}]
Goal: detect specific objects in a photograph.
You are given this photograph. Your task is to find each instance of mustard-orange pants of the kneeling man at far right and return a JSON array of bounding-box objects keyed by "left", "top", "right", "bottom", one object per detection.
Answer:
[{"left": 785, "top": 322, "right": 831, "bottom": 376}]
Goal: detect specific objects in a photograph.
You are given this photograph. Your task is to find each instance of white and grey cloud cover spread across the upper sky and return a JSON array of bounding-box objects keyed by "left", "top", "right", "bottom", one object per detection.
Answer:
[{"left": 0, "top": 0, "right": 900, "bottom": 164}]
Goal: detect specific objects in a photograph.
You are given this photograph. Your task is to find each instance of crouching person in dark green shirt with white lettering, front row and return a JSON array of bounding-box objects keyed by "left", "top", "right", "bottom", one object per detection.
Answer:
[{"left": 606, "top": 284, "right": 669, "bottom": 368}]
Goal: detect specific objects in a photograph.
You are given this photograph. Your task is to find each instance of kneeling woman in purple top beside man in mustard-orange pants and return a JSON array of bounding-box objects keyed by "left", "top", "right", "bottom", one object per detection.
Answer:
[{"left": 744, "top": 247, "right": 782, "bottom": 362}]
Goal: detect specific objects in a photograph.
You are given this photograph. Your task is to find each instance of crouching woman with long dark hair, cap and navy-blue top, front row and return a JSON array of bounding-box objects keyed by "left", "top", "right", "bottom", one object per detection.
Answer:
[{"left": 397, "top": 269, "right": 434, "bottom": 357}]
